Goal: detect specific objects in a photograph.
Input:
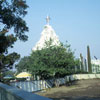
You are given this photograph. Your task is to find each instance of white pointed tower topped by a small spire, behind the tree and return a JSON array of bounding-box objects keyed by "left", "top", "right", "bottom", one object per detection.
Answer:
[{"left": 32, "top": 16, "right": 60, "bottom": 51}]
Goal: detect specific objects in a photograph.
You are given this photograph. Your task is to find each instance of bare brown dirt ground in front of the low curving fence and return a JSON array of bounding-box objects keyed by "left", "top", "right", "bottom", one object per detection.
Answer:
[{"left": 37, "top": 79, "right": 100, "bottom": 100}]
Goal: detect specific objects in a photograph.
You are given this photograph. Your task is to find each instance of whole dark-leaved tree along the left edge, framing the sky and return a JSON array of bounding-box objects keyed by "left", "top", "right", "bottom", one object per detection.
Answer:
[{"left": 0, "top": 0, "right": 28, "bottom": 77}]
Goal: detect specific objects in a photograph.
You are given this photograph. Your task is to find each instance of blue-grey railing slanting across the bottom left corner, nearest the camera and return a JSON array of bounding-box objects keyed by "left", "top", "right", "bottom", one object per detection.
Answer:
[{"left": 0, "top": 83, "right": 51, "bottom": 100}]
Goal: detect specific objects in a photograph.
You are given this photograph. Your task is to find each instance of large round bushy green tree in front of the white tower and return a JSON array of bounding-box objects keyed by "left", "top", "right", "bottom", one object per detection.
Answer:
[{"left": 17, "top": 42, "right": 76, "bottom": 79}]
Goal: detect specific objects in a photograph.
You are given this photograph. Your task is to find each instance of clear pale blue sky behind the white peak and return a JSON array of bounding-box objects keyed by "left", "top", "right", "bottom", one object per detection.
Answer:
[{"left": 9, "top": 0, "right": 100, "bottom": 59}]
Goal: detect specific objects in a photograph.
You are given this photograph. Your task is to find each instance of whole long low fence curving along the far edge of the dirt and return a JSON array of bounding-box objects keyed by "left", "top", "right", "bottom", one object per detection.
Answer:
[{"left": 10, "top": 74, "right": 100, "bottom": 92}]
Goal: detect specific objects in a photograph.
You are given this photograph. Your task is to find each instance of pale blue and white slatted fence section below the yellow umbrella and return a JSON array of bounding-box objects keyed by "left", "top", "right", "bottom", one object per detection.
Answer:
[{"left": 10, "top": 80, "right": 49, "bottom": 92}]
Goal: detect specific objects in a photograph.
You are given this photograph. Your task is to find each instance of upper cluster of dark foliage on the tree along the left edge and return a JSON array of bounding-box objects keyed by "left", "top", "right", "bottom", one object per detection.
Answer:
[{"left": 0, "top": 0, "right": 28, "bottom": 40}]
